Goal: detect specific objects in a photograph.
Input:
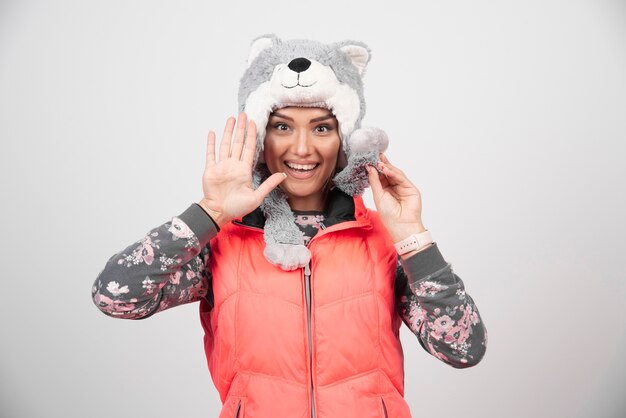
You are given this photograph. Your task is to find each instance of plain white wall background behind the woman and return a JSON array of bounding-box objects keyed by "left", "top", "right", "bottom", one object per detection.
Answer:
[{"left": 0, "top": 0, "right": 626, "bottom": 418}]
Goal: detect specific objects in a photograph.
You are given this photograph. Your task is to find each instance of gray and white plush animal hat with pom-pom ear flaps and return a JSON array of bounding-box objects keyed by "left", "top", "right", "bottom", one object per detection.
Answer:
[{"left": 239, "top": 34, "right": 388, "bottom": 270}]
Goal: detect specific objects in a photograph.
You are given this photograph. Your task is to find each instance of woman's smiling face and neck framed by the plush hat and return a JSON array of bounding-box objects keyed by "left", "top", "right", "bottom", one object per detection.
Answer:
[{"left": 263, "top": 107, "right": 341, "bottom": 210}]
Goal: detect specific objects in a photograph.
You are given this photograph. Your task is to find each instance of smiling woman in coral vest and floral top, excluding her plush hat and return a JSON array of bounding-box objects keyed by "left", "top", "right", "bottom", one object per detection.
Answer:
[{"left": 92, "top": 36, "right": 487, "bottom": 418}]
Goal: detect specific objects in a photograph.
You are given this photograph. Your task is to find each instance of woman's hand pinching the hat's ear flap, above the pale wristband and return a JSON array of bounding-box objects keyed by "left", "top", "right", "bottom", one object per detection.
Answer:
[{"left": 366, "top": 154, "right": 426, "bottom": 242}]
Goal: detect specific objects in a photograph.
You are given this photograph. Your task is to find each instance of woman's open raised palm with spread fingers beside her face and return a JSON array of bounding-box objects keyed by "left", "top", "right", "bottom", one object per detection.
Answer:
[{"left": 198, "top": 112, "right": 286, "bottom": 227}]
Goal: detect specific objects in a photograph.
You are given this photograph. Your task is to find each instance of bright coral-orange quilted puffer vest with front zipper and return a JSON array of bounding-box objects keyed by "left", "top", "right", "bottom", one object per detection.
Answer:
[{"left": 200, "top": 193, "right": 411, "bottom": 418}]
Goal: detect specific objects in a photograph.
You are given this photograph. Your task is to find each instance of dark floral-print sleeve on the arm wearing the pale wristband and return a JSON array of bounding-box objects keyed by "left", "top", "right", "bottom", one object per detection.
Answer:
[{"left": 396, "top": 243, "right": 487, "bottom": 368}]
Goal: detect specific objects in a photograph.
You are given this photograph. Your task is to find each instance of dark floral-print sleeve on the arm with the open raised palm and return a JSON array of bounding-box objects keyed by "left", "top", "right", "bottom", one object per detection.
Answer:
[{"left": 92, "top": 203, "right": 217, "bottom": 319}]
